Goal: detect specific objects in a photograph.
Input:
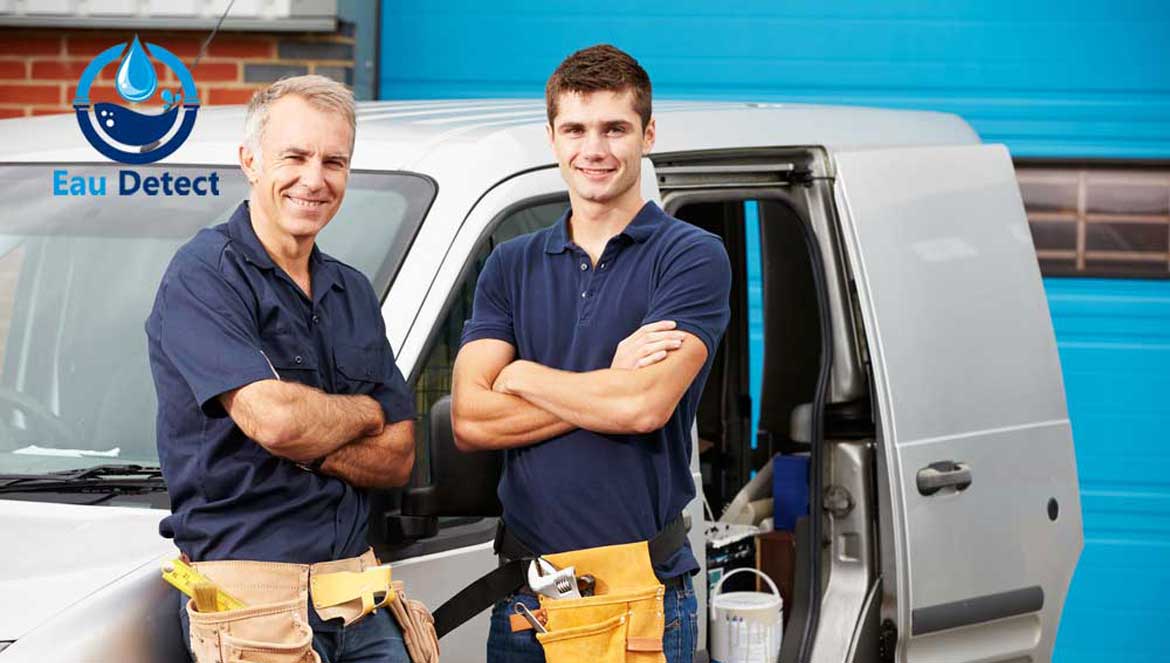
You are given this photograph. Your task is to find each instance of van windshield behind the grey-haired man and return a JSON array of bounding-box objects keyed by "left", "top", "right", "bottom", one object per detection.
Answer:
[{"left": 0, "top": 165, "right": 435, "bottom": 474}]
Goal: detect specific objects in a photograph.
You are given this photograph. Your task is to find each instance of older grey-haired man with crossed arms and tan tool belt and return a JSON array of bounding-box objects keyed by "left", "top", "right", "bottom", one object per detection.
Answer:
[{"left": 146, "top": 76, "right": 414, "bottom": 663}]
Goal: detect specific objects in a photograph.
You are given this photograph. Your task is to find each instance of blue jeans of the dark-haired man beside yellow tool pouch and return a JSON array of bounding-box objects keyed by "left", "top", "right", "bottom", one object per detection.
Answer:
[{"left": 488, "top": 574, "right": 698, "bottom": 663}]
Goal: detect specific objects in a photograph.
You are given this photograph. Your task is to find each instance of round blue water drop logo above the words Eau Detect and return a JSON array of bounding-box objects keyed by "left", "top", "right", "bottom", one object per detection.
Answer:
[{"left": 74, "top": 35, "right": 199, "bottom": 164}]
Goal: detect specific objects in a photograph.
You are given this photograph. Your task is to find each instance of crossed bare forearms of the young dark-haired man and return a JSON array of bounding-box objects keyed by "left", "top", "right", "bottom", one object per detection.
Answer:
[{"left": 452, "top": 320, "right": 707, "bottom": 451}]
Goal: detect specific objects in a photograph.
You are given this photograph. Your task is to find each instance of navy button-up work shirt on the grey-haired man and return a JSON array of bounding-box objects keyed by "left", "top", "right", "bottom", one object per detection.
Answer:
[{"left": 146, "top": 202, "right": 414, "bottom": 564}]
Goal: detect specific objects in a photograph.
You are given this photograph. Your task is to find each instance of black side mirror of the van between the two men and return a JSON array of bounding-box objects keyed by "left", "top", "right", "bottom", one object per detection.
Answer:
[{"left": 401, "top": 395, "right": 503, "bottom": 523}]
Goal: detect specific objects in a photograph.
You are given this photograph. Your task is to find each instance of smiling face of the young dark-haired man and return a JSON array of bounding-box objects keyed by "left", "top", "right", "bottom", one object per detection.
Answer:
[{"left": 549, "top": 90, "right": 654, "bottom": 206}]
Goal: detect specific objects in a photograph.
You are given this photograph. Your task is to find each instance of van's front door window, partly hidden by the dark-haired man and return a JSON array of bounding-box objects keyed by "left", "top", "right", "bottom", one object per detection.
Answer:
[{"left": 414, "top": 196, "right": 569, "bottom": 485}]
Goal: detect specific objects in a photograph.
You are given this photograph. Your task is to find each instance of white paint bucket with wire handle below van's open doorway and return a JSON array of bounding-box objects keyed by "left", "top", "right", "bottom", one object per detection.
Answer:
[{"left": 708, "top": 568, "right": 784, "bottom": 663}]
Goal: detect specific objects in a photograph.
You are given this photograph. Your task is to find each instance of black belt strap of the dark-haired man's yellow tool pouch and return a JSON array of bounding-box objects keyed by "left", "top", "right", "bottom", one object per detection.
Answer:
[{"left": 434, "top": 514, "right": 689, "bottom": 637}]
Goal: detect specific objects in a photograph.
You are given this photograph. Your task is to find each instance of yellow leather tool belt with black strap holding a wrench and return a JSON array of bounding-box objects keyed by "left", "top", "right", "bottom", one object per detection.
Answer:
[{"left": 434, "top": 516, "right": 687, "bottom": 663}]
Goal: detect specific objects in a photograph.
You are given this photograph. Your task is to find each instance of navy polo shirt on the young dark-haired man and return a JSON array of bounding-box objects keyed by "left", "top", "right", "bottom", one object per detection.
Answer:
[{"left": 462, "top": 202, "right": 731, "bottom": 579}]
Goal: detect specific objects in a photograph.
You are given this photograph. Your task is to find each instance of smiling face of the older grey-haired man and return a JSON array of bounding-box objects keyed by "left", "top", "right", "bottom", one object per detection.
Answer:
[{"left": 240, "top": 95, "right": 353, "bottom": 241}]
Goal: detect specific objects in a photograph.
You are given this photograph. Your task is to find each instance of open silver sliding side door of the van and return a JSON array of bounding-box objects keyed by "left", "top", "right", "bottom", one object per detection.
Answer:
[{"left": 834, "top": 145, "right": 1082, "bottom": 662}]
